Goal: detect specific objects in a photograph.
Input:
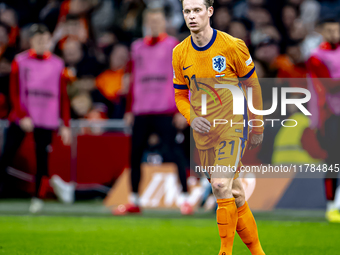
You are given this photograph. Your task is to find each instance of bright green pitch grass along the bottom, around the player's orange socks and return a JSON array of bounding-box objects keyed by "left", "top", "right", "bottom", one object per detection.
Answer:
[{"left": 0, "top": 216, "right": 340, "bottom": 255}]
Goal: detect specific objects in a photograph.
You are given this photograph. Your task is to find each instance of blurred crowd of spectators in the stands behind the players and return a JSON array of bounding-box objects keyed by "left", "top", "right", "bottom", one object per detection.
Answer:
[{"left": 0, "top": 0, "right": 340, "bottom": 119}]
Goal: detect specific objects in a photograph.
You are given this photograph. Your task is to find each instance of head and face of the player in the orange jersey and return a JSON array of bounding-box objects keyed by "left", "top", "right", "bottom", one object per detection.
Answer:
[{"left": 183, "top": 0, "right": 214, "bottom": 33}]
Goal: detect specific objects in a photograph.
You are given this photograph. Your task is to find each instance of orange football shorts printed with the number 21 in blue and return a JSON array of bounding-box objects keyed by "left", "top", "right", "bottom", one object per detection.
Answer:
[{"left": 198, "top": 137, "right": 247, "bottom": 179}]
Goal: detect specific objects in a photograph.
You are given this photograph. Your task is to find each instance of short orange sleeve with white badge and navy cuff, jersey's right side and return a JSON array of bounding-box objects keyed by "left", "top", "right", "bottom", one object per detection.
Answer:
[{"left": 233, "top": 39, "right": 255, "bottom": 78}]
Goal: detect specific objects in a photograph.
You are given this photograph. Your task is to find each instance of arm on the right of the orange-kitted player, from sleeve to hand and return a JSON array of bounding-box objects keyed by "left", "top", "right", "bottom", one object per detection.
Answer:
[{"left": 234, "top": 40, "right": 264, "bottom": 149}]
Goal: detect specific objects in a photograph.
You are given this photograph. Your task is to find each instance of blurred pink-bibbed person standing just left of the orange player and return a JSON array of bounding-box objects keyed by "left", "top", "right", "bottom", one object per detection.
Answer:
[{"left": 114, "top": 9, "right": 193, "bottom": 215}]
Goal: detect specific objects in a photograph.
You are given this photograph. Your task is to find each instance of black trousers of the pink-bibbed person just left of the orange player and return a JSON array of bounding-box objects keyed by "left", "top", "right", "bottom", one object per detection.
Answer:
[{"left": 131, "top": 115, "right": 188, "bottom": 193}]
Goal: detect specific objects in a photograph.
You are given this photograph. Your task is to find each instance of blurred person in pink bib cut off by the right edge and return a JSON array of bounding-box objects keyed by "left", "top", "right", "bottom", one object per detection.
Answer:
[{"left": 307, "top": 19, "right": 340, "bottom": 223}]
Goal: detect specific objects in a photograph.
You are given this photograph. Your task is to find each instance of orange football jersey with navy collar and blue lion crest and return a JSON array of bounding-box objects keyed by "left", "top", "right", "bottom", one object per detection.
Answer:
[{"left": 172, "top": 30, "right": 263, "bottom": 150}]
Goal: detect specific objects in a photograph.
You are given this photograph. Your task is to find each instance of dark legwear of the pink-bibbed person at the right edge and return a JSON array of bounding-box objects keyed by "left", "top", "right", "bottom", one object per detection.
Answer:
[{"left": 318, "top": 115, "right": 340, "bottom": 200}]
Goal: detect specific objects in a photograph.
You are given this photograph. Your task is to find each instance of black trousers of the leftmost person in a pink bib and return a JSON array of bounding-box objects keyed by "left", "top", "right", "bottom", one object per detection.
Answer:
[{"left": 0, "top": 123, "right": 53, "bottom": 197}]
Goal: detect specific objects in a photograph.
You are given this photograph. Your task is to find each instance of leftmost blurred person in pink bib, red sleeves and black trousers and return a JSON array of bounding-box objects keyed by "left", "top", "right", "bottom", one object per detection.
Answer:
[{"left": 0, "top": 24, "right": 71, "bottom": 213}]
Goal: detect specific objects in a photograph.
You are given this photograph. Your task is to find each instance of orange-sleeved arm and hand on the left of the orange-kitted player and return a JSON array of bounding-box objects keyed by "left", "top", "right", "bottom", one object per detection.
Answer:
[{"left": 172, "top": 47, "right": 211, "bottom": 133}]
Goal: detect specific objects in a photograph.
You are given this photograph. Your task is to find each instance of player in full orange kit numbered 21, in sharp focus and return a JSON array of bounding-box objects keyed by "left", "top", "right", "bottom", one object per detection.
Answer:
[{"left": 173, "top": 0, "right": 264, "bottom": 255}]
